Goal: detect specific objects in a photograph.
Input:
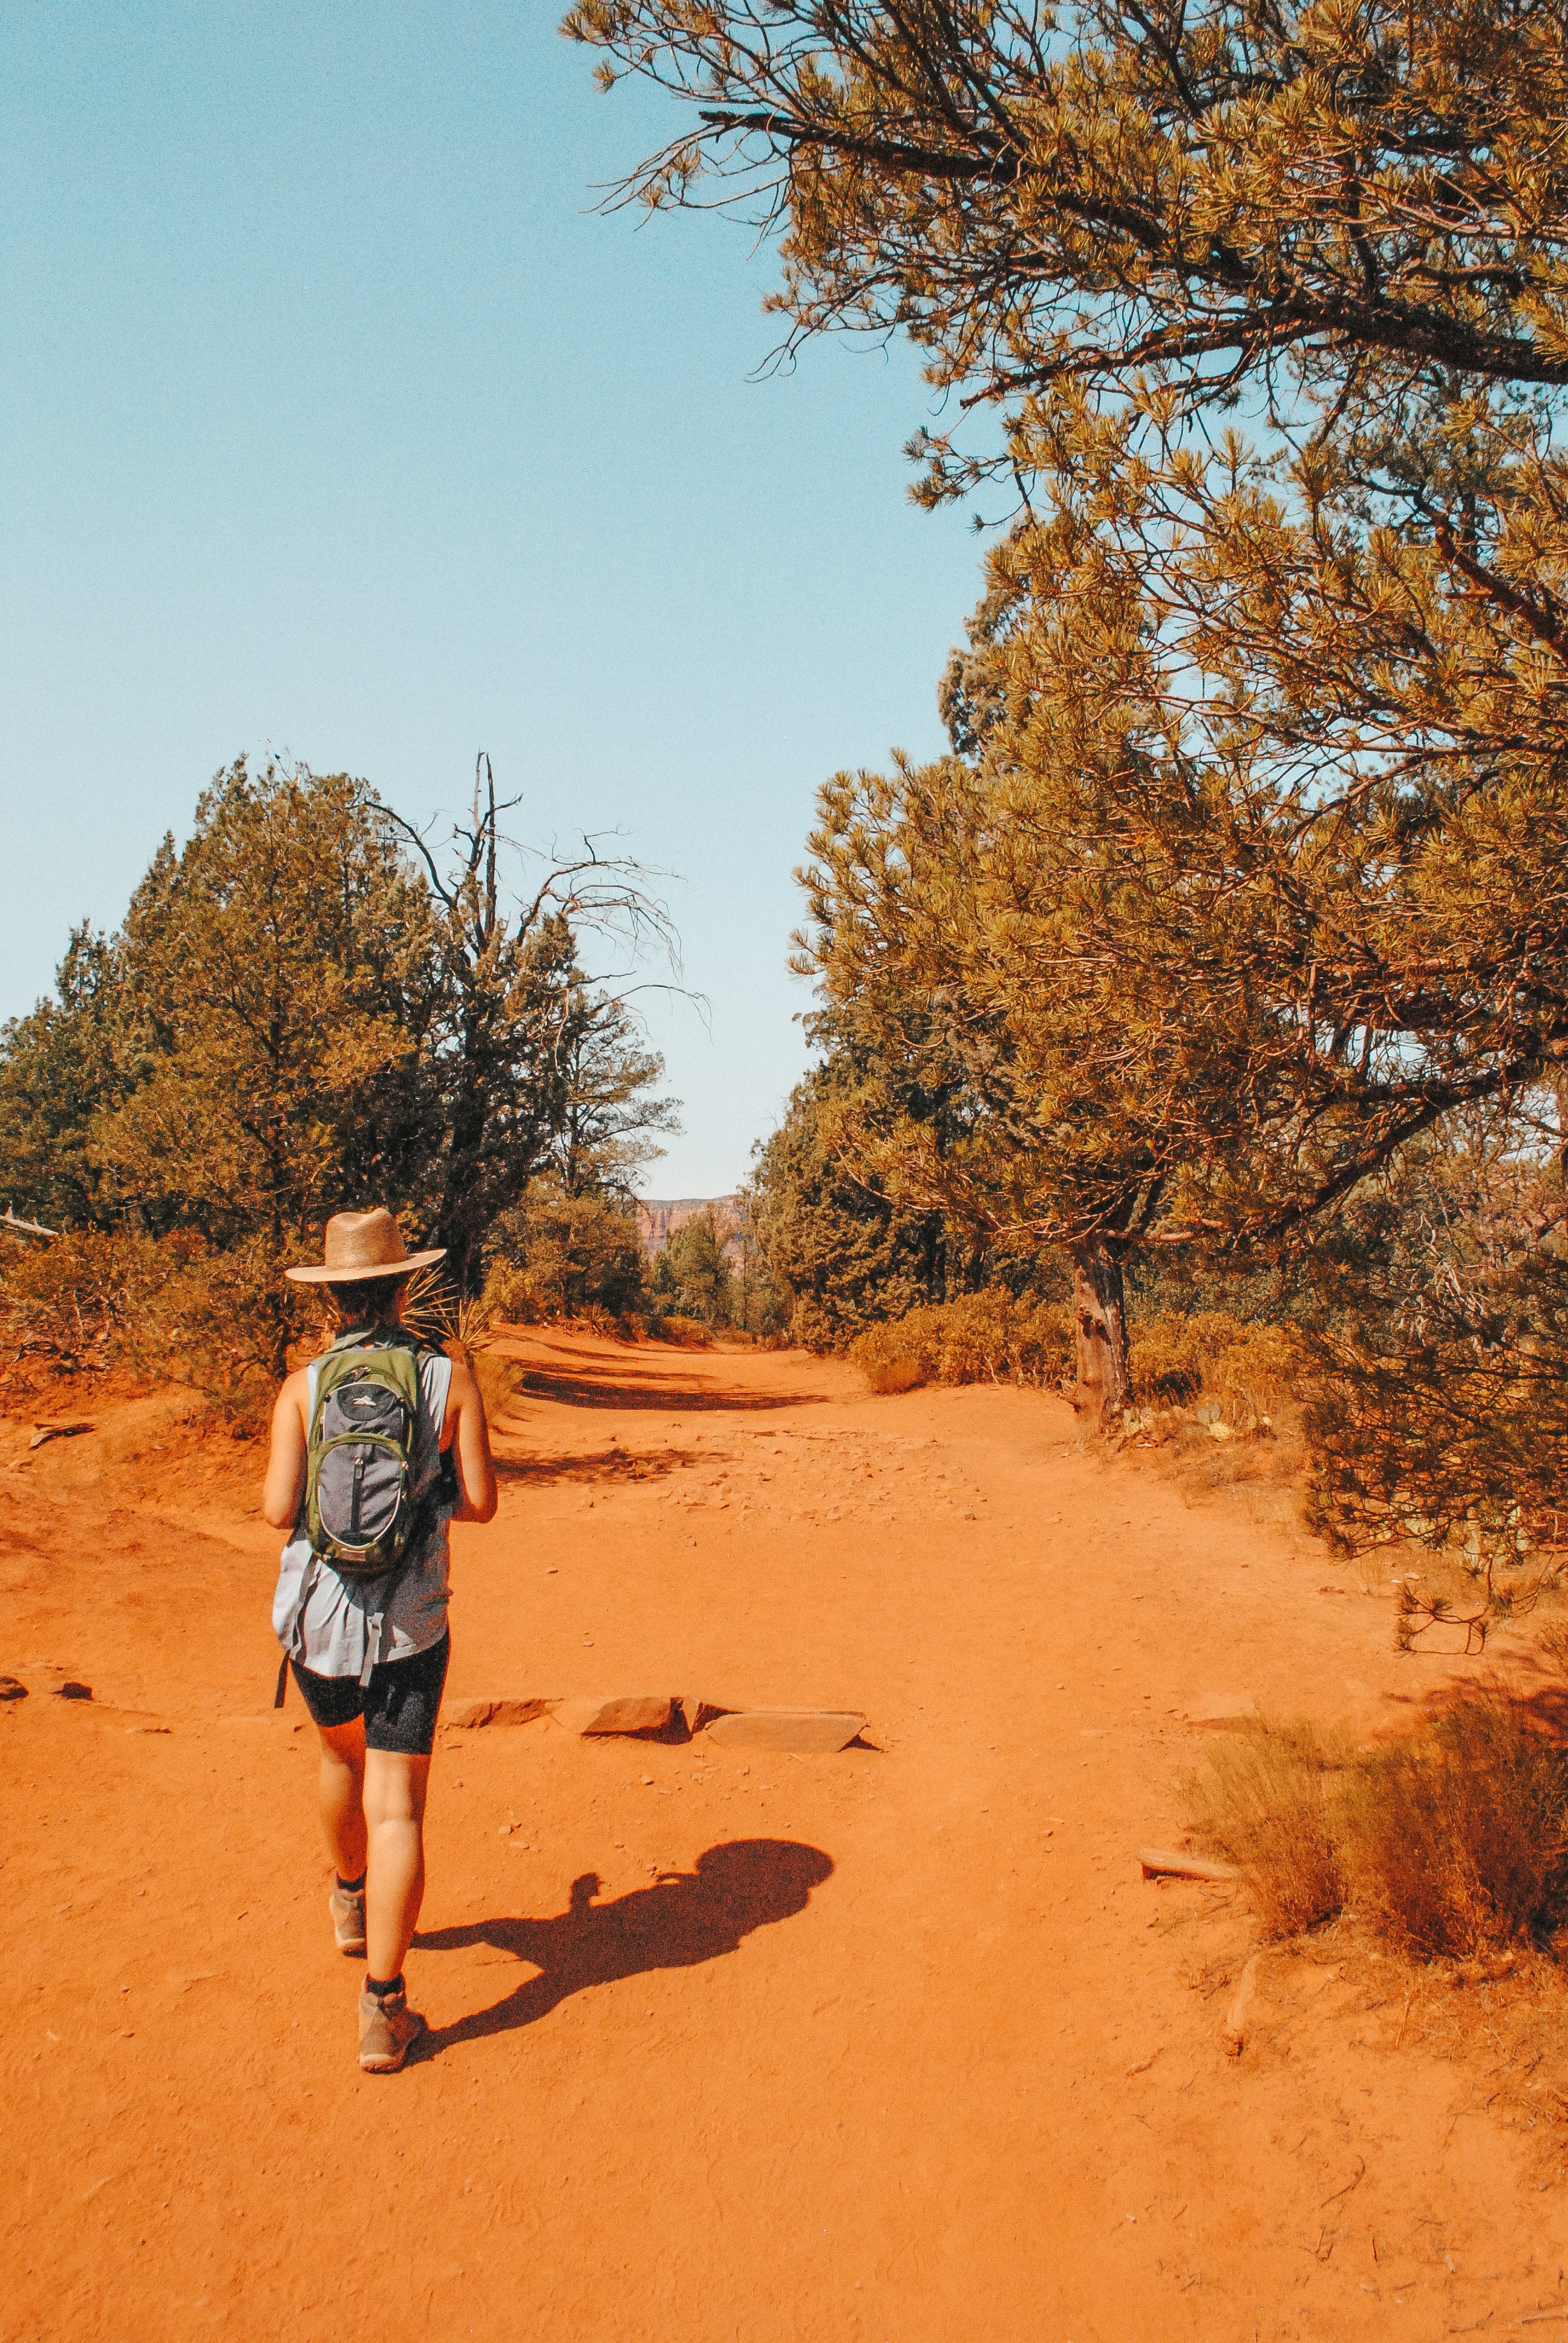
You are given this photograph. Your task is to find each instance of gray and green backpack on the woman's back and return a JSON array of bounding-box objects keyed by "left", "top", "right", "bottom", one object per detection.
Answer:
[{"left": 305, "top": 1326, "right": 420, "bottom": 1579}]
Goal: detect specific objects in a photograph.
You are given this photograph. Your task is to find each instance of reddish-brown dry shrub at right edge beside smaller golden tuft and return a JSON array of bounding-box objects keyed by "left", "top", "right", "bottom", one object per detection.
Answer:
[{"left": 1341, "top": 1692, "right": 1568, "bottom": 1959}]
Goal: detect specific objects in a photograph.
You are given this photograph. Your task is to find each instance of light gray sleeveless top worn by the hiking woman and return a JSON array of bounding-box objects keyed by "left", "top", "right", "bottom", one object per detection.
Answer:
[{"left": 272, "top": 1352, "right": 457, "bottom": 1685}]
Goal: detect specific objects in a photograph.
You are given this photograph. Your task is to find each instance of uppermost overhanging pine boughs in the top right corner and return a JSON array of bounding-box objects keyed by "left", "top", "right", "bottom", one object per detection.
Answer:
[{"left": 563, "top": 0, "right": 1568, "bottom": 440}]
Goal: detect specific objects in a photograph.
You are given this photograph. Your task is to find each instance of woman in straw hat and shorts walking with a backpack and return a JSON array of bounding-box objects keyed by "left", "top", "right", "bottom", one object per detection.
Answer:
[{"left": 263, "top": 1207, "right": 497, "bottom": 2074}]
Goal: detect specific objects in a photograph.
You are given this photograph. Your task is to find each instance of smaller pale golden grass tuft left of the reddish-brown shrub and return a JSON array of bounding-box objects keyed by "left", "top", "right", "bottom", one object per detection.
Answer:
[{"left": 1188, "top": 1720, "right": 1345, "bottom": 1935}]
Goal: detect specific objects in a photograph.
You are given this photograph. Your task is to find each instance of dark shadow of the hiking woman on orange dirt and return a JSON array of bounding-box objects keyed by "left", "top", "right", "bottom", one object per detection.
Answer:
[{"left": 415, "top": 1840, "right": 832, "bottom": 2057}]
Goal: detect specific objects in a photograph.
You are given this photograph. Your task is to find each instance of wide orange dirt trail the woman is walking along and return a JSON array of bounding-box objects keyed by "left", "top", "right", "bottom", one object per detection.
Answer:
[{"left": 0, "top": 1333, "right": 1568, "bottom": 2343}]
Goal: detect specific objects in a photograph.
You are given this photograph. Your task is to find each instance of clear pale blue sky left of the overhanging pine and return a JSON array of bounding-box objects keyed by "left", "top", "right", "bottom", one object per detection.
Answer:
[{"left": 0, "top": 0, "right": 980, "bottom": 1195}]
